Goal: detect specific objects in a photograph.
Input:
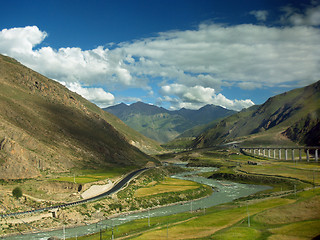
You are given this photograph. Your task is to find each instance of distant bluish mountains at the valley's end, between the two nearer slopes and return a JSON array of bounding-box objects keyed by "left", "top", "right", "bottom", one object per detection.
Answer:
[{"left": 104, "top": 102, "right": 235, "bottom": 143}]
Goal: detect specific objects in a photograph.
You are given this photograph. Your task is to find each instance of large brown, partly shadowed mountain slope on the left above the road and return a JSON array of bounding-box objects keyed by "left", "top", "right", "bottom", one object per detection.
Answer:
[{"left": 0, "top": 55, "right": 157, "bottom": 179}]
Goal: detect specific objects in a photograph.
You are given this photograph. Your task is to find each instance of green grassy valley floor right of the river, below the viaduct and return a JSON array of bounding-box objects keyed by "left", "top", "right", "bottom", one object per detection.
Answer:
[{"left": 67, "top": 149, "right": 320, "bottom": 239}]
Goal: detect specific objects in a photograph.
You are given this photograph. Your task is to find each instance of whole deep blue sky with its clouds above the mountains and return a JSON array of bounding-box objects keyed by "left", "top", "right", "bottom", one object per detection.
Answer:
[{"left": 0, "top": 0, "right": 320, "bottom": 110}]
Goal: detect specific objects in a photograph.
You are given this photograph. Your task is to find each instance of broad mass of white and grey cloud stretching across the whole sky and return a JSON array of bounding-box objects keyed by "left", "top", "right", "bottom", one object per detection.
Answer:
[{"left": 0, "top": 3, "right": 320, "bottom": 110}]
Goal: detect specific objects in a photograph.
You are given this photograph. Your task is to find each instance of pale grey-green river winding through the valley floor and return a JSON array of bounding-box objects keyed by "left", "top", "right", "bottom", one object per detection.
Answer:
[{"left": 4, "top": 167, "right": 270, "bottom": 240}]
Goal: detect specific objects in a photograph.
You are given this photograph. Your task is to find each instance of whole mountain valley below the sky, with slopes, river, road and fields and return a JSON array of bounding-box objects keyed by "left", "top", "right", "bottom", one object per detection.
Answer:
[{"left": 0, "top": 55, "right": 320, "bottom": 240}]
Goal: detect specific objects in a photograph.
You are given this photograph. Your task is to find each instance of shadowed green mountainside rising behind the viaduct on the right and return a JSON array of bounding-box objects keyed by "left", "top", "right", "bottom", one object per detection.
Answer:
[{"left": 193, "top": 81, "right": 320, "bottom": 147}]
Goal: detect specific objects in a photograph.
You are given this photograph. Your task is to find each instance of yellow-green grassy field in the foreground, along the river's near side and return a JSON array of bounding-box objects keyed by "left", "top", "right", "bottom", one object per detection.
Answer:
[{"left": 71, "top": 189, "right": 320, "bottom": 240}]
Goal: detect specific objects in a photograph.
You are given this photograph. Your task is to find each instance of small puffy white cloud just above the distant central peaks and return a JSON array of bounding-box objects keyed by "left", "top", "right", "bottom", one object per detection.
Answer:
[{"left": 159, "top": 84, "right": 254, "bottom": 111}]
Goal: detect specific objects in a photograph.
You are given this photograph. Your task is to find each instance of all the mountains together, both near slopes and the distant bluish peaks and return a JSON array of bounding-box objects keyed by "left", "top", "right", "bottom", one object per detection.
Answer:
[{"left": 0, "top": 55, "right": 320, "bottom": 179}]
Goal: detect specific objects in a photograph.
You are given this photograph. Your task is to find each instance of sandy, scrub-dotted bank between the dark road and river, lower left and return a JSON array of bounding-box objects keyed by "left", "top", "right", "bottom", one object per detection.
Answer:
[{"left": 2, "top": 167, "right": 210, "bottom": 236}]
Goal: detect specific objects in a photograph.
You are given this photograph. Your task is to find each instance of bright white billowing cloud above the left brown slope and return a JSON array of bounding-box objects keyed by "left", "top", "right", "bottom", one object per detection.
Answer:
[{"left": 0, "top": 26, "right": 134, "bottom": 86}]
